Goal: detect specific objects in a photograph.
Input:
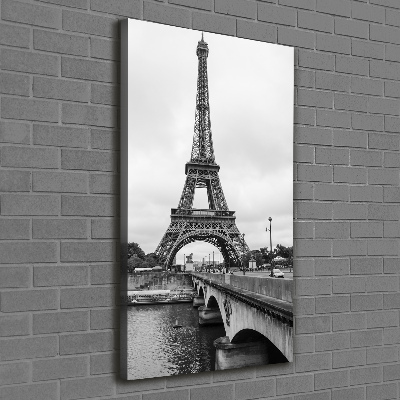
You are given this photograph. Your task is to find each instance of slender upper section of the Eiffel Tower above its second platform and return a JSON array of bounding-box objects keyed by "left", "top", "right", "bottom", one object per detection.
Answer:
[{"left": 190, "top": 32, "right": 216, "bottom": 165}]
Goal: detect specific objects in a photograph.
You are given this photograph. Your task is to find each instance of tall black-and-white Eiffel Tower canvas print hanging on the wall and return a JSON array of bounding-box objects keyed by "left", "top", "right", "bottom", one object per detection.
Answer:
[{"left": 121, "top": 20, "right": 294, "bottom": 380}]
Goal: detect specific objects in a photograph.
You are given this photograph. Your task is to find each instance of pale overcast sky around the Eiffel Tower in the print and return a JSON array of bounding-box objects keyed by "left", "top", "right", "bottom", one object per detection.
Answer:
[{"left": 128, "top": 20, "right": 294, "bottom": 263}]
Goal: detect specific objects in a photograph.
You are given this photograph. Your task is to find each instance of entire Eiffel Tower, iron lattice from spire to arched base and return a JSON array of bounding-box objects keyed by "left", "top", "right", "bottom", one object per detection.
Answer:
[{"left": 155, "top": 34, "right": 249, "bottom": 267}]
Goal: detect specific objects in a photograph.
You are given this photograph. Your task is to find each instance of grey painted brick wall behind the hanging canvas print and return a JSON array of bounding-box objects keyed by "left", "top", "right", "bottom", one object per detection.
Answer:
[{"left": 0, "top": 0, "right": 400, "bottom": 400}]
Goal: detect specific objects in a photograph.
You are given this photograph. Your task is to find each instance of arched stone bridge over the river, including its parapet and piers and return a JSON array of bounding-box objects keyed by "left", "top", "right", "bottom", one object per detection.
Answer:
[{"left": 191, "top": 272, "right": 293, "bottom": 369}]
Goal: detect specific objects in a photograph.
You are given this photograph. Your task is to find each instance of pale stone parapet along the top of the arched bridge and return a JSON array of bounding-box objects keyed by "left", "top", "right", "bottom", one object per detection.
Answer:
[{"left": 192, "top": 272, "right": 293, "bottom": 303}]
